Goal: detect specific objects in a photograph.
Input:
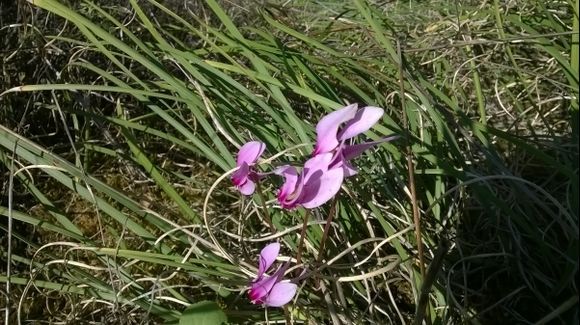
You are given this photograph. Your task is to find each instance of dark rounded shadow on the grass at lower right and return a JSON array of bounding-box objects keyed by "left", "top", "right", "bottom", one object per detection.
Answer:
[{"left": 439, "top": 133, "right": 579, "bottom": 324}]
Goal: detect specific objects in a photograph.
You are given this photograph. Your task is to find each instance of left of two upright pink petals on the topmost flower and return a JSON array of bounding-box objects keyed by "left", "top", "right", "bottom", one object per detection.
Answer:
[{"left": 313, "top": 104, "right": 358, "bottom": 155}]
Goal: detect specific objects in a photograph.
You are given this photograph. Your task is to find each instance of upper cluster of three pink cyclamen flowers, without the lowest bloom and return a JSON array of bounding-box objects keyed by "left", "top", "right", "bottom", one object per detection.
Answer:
[{"left": 232, "top": 104, "right": 395, "bottom": 209}]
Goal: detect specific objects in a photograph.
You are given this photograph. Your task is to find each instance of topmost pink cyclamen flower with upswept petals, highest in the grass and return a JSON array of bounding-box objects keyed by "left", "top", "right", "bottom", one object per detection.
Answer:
[{"left": 312, "top": 104, "right": 396, "bottom": 177}]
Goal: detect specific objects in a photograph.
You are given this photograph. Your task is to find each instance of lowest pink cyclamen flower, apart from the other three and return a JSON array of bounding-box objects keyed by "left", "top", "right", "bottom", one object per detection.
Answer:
[{"left": 248, "top": 243, "right": 298, "bottom": 307}]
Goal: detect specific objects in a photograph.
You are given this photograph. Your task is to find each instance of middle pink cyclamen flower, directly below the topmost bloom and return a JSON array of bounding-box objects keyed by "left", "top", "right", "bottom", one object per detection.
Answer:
[{"left": 275, "top": 153, "right": 344, "bottom": 209}]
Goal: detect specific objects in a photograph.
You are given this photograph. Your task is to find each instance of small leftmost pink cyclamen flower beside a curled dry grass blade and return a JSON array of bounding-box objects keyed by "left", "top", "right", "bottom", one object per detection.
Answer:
[{"left": 232, "top": 141, "right": 266, "bottom": 195}]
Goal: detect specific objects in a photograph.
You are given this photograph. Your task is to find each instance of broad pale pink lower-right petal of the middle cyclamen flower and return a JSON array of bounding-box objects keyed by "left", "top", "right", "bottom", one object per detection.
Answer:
[{"left": 299, "top": 168, "right": 344, "bottom": 209}]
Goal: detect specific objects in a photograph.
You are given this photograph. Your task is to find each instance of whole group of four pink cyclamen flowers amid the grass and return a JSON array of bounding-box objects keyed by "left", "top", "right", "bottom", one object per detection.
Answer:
[{"left": 232, "top": 104, "right": 395, "bottom": 307}]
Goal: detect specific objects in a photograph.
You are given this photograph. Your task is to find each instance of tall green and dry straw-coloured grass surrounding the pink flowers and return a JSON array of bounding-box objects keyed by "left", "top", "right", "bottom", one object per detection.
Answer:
[{"left": 0, "top": 0, "right": 579, "bottom": 324}]
